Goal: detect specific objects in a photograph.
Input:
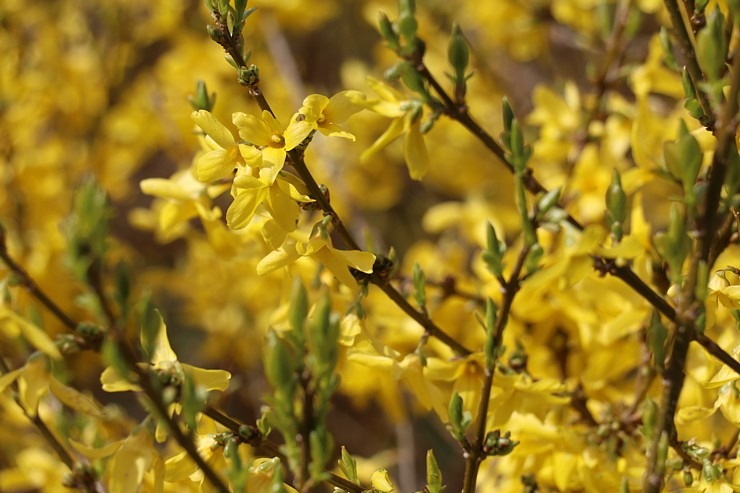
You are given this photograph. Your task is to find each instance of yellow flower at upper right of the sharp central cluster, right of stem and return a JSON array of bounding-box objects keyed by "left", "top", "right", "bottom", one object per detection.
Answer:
[{"left": 298, "top": 91, "right": 365, "bottom": 140}]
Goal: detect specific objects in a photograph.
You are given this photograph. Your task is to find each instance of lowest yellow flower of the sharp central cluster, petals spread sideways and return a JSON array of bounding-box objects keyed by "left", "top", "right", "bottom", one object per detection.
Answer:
[{"left": 257, "top": 232, "right": 375, "bottom": 287}]
